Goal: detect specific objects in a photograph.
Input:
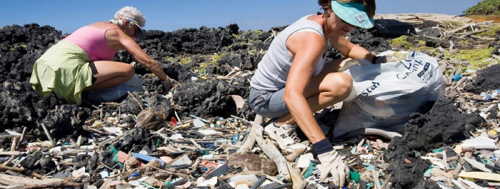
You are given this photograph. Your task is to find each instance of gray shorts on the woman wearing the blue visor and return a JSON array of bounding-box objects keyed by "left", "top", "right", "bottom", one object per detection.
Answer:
[{"left": 248, "top": 87, "right": 289, "bottom": 118}]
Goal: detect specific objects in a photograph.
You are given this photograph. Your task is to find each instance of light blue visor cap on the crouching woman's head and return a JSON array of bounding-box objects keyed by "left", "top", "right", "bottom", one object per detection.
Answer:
[{"left": 332, "top": 0, "right": 374, "bottom": 29}]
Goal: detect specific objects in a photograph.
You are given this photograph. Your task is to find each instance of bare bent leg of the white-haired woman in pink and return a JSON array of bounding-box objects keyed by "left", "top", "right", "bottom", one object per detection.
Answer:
[{"left": 85, "top": 61, "right": 135, "bottom": 91}]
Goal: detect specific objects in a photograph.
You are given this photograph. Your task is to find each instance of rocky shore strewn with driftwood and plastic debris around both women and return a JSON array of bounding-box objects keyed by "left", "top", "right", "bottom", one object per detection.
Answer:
[{"left": 0, "top": 14, "right": 500, "bottom": 189}]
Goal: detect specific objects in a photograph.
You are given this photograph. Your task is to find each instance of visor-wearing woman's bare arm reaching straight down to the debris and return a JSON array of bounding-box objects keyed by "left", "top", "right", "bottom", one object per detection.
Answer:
[{"left": 283, "top": 32, "right": 326, "bottom": 144}]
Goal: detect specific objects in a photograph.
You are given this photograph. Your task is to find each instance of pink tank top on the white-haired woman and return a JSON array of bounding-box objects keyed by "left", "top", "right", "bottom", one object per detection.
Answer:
[{"left": 63, "top": 26, "right": 116, "bottom": 61}]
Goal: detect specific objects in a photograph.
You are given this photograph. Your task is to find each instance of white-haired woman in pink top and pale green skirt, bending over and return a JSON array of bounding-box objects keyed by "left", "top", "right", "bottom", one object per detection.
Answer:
[{"left": 30, "top": 6, "right": 176, "bottom": 104}]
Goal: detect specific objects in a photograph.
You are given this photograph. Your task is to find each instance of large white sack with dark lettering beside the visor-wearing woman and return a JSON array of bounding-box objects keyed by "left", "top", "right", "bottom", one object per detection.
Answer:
[{"left": 333, "top": 51, "right": 445, "bottom": 138}]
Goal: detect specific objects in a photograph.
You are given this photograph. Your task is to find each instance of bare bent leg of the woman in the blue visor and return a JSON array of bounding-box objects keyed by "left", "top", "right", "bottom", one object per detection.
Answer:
[{"left": 276, "top": 59, "right": 352, "bottom": 125}]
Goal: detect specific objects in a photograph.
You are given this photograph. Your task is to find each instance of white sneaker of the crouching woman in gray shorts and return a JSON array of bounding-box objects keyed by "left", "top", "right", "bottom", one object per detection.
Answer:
[{"left": 264, "top": 121, "right": 307, "bottom": 152}]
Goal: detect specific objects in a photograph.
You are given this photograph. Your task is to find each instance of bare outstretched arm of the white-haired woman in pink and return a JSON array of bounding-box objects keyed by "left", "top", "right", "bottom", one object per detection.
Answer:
[{"left": 109, "top": 30, "right": 168, "bottom": 81}]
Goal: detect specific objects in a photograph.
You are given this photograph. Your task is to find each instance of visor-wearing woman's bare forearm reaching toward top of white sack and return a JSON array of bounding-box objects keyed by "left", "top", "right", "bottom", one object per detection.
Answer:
[{"left": 330, "top": 37, "right": 374, "bottom": 62}]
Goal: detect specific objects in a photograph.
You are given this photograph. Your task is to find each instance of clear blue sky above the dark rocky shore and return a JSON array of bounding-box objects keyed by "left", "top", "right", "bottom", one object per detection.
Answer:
[{"left": 0, "top": 0, "right": 481, "bottom": 33}]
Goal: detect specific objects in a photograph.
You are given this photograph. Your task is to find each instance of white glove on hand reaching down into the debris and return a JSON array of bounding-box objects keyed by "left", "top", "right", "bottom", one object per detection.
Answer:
[{"left": 318, "top": 150, "right": 350, "bottom": 187}]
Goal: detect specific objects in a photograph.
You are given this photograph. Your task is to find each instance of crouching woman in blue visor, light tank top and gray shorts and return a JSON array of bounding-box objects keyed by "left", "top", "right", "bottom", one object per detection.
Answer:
[{"left": 249, "top": 0, "right": 383, "bottom": 187}]
